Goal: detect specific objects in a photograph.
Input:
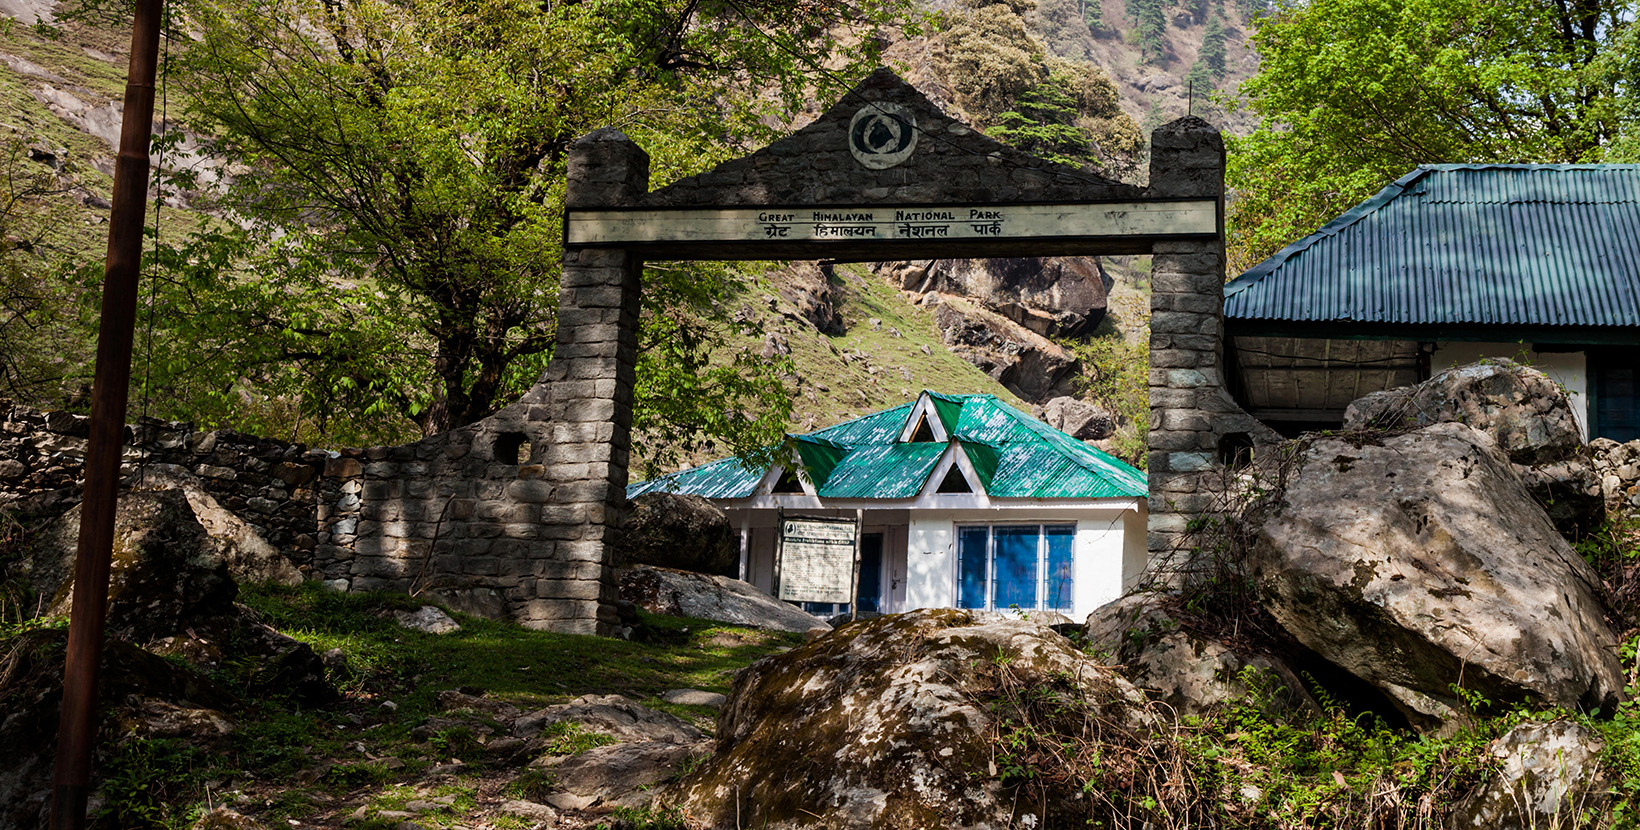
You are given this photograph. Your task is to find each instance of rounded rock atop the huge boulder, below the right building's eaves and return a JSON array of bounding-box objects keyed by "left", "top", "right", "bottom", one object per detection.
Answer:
[{"left": 1343, "top": 359, "right": 1583, "bottom": 466}]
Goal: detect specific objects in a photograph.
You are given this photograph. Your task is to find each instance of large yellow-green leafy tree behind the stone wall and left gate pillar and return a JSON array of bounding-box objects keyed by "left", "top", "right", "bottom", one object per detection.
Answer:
[{"left": 121, "top": 0, "right": 889, "bottom": 449}]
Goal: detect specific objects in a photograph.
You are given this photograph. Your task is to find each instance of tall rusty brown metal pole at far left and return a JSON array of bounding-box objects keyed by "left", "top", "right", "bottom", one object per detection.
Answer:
[{"left": 49, "top": 0, "right": 164, "bottom": 830}]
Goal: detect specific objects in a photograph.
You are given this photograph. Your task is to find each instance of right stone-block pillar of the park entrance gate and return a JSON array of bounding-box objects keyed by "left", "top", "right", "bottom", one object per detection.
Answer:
[{"left": 1146, "top": 116, "right": 1279, "bottom": 561}]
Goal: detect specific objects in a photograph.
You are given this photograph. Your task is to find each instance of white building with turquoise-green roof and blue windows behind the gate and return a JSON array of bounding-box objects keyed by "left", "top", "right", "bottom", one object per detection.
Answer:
[{"left": 626, "top": 392, "right": 1148, "bottom": 620}]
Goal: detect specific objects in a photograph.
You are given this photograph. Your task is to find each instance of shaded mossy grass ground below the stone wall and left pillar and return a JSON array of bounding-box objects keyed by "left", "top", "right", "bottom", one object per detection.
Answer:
[{"left": 0, "top": 582, "right": 800, "bottom": 828}]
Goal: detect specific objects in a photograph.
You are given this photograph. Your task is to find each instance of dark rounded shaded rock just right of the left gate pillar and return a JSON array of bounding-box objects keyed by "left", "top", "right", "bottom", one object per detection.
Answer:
[{"left": 615, "top": 492, "right": 740, "bottom": 576}]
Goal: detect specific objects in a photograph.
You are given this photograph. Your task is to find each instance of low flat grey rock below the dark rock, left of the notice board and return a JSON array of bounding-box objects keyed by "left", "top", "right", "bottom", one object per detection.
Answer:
[{"left": 620, "top": 566, "right": 828, "bottom": 632}]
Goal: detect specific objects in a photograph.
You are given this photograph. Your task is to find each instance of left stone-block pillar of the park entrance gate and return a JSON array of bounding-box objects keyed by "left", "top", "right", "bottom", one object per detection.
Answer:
[{"left": 522, "top": 128, "right": 649, "bottom": 635}]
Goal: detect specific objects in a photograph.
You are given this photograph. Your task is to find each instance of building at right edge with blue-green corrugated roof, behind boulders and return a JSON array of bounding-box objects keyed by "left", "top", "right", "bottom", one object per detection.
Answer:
[{"left": 1225, "top": 164, "right": 1640, "bottom": 441}]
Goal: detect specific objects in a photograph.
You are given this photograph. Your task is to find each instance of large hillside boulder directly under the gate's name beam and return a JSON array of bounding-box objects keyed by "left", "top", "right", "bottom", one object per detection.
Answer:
[{"left": 874, "top": 256, "right": 1112, "bottom": 338}]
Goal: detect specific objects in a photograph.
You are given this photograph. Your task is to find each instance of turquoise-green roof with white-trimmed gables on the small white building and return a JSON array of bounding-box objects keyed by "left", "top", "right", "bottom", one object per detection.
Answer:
[{"left": 626, "top": 392, "right": 1148, "bottom": 499}]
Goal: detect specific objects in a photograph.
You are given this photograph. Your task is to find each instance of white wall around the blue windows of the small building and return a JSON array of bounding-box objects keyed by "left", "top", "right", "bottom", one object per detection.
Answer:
[{"left": 900, "top": 502, "right": 1146, "bottom": 620}]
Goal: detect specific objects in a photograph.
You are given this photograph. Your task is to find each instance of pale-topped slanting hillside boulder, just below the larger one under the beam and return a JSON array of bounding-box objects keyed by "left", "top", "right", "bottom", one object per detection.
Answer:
[{"left": 923, "top": 294, "right": 1077, "bottom": 402}]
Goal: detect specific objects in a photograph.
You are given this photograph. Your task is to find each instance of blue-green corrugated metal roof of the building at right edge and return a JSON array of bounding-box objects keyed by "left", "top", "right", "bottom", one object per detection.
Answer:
[{"left": 1225, "top": 164, "right": 1640, "bottom": 326}]
